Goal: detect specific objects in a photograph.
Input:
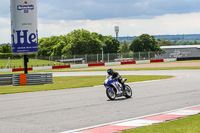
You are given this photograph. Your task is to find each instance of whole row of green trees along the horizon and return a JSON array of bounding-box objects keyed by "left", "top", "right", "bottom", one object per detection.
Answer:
[{"left": 0, "top": 29, "right": 198, "bottom": 56}]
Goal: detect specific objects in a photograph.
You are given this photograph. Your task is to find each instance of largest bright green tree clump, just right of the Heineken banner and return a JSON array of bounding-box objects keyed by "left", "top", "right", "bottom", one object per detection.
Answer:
[{"left": 38, "top": 29, "right": 119, "bottom": 56}]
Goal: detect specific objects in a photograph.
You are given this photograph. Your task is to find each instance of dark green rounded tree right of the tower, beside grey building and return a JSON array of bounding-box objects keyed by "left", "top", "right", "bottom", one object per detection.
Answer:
[{"left": 130, "top": 34, "right": 163, "bottom": 52}]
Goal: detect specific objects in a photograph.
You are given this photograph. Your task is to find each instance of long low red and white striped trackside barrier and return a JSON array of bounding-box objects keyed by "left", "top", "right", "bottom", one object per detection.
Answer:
[{"left": 0, "top": 58, "right": 177, "bottom": 72}]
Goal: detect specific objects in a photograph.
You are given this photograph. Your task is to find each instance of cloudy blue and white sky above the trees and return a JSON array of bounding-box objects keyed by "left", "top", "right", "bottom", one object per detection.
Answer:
[{"left": 0, "top": 0, "right": 200, "bottom": 43}]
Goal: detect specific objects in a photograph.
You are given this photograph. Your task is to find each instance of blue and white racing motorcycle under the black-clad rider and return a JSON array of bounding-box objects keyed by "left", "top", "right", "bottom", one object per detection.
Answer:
[{"left": 103, "top": 76, "right": 132, "bottom": 100}]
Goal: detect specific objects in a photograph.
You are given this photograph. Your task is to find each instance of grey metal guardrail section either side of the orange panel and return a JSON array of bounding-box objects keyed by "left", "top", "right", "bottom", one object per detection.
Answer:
[{"left": 13, "top": 73, "right": 53, "bottom": 86}]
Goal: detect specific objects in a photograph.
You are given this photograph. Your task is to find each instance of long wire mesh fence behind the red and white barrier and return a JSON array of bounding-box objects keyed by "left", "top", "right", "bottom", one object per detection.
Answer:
[{"left": 0, "top": 52, "right": 160, "bottom": 69}]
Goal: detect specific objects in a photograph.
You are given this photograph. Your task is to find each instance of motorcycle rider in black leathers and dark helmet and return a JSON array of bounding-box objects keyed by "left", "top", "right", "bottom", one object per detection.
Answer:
[{"left": 107, "top": 68, "right": 125, "bottom": 93}]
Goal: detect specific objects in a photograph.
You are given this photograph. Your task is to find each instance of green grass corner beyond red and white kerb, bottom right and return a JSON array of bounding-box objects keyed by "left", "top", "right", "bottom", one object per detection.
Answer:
[{"left": 122, "top": 115, "right": 200, "bottom": 133}]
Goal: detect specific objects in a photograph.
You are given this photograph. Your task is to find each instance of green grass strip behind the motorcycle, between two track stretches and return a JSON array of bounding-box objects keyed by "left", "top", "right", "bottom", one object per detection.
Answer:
[{"left": 0, "top": 75, "right": 173, "bottom": 94}]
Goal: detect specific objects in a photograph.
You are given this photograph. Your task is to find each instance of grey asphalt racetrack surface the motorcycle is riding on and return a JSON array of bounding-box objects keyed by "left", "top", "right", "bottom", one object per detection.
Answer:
[{"left": 0, "top": 70, "right": 200, "bottom": 133}]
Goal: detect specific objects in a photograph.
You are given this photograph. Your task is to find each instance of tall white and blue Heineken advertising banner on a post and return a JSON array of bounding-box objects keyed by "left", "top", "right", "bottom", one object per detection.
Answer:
[{"left": 10, "top": 0, "right": 38, "bottom": 55}]
